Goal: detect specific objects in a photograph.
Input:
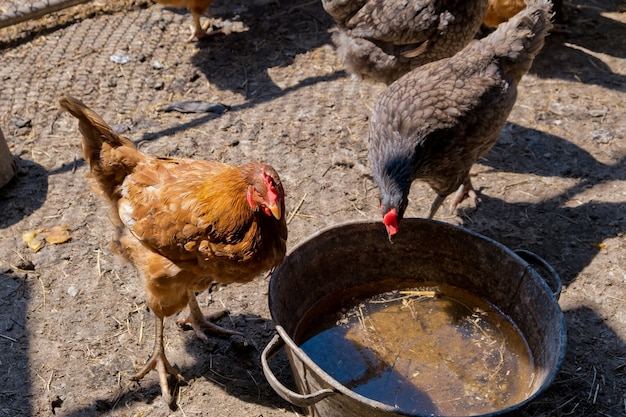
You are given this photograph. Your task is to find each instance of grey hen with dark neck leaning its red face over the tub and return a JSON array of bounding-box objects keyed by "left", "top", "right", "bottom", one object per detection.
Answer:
[{"left": 368, "top": 0, "right": 552, "bottom": 239}]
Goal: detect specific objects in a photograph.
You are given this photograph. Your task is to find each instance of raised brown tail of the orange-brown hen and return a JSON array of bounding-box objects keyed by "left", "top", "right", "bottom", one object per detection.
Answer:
[{"left": 58, "top": 96, "right": 145, "bottom": 197}]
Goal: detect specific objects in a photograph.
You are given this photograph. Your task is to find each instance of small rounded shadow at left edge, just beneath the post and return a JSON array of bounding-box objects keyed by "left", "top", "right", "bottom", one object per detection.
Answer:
[{"left": 0, "top": 158, "right": 49, "bottom": 229}]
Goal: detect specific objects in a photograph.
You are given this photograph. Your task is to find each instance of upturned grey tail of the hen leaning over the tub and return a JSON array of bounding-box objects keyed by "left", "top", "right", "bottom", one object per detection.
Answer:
[{"left": 488, "top": 0, "right": 554, "bottom": 77}]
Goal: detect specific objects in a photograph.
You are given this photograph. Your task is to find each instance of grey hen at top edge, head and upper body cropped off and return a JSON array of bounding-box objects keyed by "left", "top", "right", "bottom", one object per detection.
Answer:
[{"left": 322, "top": 0, "right": 487, "bottom": 84}]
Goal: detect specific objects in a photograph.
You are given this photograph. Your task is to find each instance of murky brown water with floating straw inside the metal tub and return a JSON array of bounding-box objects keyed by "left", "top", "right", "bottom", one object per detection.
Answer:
[{"left": 301, "top": 284, "right": 533, "bottom": 416}]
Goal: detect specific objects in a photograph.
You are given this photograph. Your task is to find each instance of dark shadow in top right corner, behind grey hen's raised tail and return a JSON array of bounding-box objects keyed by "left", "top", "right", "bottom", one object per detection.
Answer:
[{"left": 529, "top": 1, "right": 626, "bottom": 91}]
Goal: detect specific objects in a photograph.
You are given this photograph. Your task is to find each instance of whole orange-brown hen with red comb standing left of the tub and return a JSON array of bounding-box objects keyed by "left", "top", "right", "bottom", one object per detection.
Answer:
[{"left": 59, "top": 97, "right": 287, "bottom": 403}]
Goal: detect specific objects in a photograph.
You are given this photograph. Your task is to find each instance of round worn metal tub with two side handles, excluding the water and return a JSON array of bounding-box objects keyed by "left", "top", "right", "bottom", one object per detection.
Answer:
[{"left": 261, "top": 219, "right": 566, "bottom": 417}]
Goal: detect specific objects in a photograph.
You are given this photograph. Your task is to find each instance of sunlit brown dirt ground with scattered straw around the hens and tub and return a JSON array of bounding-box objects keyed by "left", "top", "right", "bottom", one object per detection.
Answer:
[{"left": 0, "top": 0, "right": 626, "bottom": 417}]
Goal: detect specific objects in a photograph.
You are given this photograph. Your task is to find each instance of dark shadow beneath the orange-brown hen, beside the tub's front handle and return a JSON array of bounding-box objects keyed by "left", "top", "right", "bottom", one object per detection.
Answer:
[{"left": 61, "top": 313, "right": 298, "bottom": 417}]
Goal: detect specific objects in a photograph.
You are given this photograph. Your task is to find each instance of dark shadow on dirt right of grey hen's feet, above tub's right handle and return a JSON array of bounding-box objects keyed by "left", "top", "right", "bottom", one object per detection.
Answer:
[{"left": 461, "top": 124, "right": 626, "bottom": 285}]
